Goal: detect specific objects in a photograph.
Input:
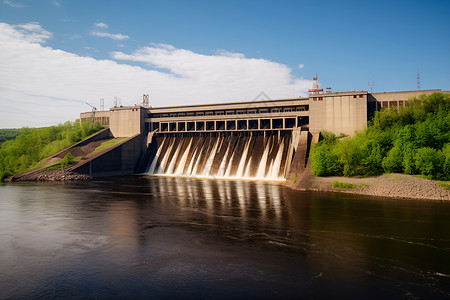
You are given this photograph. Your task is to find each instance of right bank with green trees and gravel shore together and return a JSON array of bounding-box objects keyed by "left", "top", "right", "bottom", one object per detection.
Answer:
[{"left": 294, "top": 93, "right": 450, "bottom": 200}]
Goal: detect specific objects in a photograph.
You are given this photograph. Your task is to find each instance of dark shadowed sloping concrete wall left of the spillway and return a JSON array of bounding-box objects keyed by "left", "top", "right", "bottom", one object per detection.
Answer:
[{"left": 73, "top": 134, "right": 147, "bottom": 178}]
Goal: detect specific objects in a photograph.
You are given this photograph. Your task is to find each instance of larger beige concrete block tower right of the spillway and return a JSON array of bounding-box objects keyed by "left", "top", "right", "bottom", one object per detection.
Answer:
[{"left": 309, "top": 91, "right": 367, "bottom": 136}]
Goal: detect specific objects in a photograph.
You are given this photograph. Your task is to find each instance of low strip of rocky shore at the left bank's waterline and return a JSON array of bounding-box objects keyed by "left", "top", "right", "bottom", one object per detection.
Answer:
[{"left": 5, "top": 168, "right": 92, "bottom": 182}]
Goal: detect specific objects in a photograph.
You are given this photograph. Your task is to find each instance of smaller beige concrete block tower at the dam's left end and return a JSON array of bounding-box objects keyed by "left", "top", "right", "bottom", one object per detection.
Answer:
[{"left": 109, "top": 106, "right": 147, "bottom": 137}]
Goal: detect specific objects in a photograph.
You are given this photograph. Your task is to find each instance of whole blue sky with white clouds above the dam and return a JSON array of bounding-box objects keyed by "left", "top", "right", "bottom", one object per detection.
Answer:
[{"left": 0, "top": 0, "right": 450, "bottom": 128}]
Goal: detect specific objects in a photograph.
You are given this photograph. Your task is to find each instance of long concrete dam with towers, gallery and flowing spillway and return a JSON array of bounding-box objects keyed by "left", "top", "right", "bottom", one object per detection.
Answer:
[{"left": 77, "top": 90, "right": 448, "bottom": 180}]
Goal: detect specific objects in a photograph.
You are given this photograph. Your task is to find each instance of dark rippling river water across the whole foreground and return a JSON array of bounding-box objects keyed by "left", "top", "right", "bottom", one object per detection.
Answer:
[{"left": 0, "top": 176, "right": 450, "bottom": 299}]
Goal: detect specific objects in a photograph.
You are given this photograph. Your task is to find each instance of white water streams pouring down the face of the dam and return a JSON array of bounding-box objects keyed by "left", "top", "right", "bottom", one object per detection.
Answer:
[{"left": 147, "top": 136, "right": 290, "bottom": 180}]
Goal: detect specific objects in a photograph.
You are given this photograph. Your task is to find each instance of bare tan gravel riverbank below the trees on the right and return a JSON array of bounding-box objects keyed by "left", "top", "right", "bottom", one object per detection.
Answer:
[{"left": 287, "top": 166, "right": 450, "bottom": 200}]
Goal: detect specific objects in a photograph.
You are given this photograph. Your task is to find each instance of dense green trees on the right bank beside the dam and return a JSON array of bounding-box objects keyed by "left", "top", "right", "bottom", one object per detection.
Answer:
[{"left": 310, "top": 93, "right": 450, "bottom": 180}]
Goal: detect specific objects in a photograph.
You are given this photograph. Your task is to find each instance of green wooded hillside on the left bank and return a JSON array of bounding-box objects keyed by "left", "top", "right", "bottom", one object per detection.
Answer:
[{"left": 0, "top": 120, "right": 102, "bottom": 181}]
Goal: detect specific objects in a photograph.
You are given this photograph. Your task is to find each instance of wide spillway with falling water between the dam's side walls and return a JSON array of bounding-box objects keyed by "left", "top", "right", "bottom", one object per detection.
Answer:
[{"left": 146, "top": 131, "right": 293, "bottom": 180}]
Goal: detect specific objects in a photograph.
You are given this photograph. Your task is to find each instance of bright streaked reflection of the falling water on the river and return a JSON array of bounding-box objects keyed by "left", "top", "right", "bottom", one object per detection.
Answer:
[{"left": 144, "top": 177, "right": 296, "bottom": 243}]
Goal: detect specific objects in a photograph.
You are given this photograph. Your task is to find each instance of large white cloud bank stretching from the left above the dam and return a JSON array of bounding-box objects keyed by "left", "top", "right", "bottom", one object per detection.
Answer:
[{"left": 0, "top": 23, "right": 311, "bottom": 128}]
